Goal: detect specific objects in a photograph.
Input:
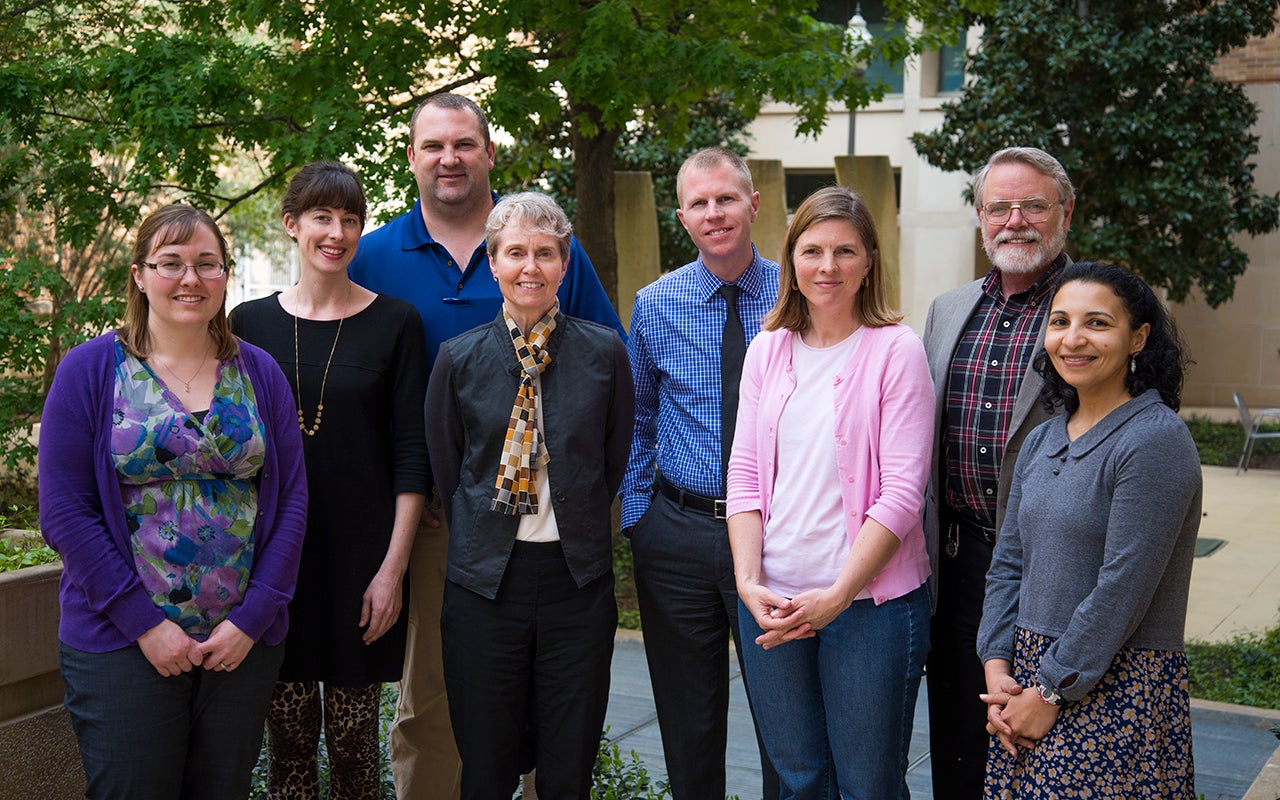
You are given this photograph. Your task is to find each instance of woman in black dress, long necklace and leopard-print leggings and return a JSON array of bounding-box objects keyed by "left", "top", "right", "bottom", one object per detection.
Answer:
[{"left": 232, "top": 161, "right": 428, "bottom": 797}]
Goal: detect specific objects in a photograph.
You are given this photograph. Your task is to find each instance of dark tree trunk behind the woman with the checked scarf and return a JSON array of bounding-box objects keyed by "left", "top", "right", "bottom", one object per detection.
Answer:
[{"left": 571, "top": 106, "right": 620, "bottom": 308}]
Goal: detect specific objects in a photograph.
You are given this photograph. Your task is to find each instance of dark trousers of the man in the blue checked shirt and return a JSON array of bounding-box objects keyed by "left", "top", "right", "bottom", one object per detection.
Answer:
[{"left": 631, "top": 494, "right": 778, "bottom": 800}]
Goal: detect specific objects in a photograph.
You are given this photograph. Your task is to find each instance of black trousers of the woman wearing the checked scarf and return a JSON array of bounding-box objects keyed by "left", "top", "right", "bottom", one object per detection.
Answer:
[{"left": 440, "top": 541, "right": 618, "bottom": 800}]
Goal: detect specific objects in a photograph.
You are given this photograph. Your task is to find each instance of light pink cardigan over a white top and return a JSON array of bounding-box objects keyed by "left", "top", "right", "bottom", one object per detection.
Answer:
[{"left": 727, "top": 325, "right": 934, "bottom": 605}]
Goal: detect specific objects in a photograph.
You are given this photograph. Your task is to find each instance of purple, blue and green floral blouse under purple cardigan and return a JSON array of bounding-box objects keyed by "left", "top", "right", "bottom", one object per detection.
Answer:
[{"left": 111, "top": 340, "right": 266, "bottom": 639}]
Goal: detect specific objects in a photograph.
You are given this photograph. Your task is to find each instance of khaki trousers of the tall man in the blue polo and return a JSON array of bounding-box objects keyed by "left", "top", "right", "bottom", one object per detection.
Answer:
[{"left": 390, "top": 512, "right": 462, "bottom": 800}]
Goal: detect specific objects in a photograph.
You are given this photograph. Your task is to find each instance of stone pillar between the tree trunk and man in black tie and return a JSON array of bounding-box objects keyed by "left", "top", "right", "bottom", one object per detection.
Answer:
[{"left": 613, "top": 172, "right": 662, "bottom": 326}]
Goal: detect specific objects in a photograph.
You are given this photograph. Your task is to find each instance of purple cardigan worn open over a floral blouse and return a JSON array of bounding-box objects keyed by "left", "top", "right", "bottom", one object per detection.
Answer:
[{"left": 38, "top": 333, "right": 307, "bottom": 653}]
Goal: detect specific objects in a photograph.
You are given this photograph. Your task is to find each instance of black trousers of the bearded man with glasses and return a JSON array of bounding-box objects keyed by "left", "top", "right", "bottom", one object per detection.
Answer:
[{"left": 924, "top": 516, "right": 995, "bottom": 800}]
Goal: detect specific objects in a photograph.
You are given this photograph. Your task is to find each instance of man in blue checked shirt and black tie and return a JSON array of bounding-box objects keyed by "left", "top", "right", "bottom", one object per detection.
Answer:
[{"left": 621, "top": 147, "right": 778, "bottom": 800}]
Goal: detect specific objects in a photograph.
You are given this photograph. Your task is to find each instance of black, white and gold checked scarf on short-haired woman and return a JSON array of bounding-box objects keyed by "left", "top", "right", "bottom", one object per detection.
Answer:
[{"left": 490, "top": 302, "right": 559, "bottom": 515}]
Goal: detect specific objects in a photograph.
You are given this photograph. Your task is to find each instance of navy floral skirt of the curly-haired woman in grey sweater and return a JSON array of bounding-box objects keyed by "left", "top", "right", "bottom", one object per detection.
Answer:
[{"left": 986, "top": 628, "right": 1196, "bottom": 800}]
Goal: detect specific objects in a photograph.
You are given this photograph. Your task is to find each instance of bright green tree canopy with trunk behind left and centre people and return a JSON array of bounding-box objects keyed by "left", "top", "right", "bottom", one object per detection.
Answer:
[{"left": 0, "top": 0, "right": 977, "bottom": 468}]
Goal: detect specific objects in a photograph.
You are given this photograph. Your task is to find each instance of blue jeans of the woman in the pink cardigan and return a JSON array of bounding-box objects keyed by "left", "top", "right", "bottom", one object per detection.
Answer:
[{"left": 737, "top": 586, "right": 929, "bottom": 800}]
